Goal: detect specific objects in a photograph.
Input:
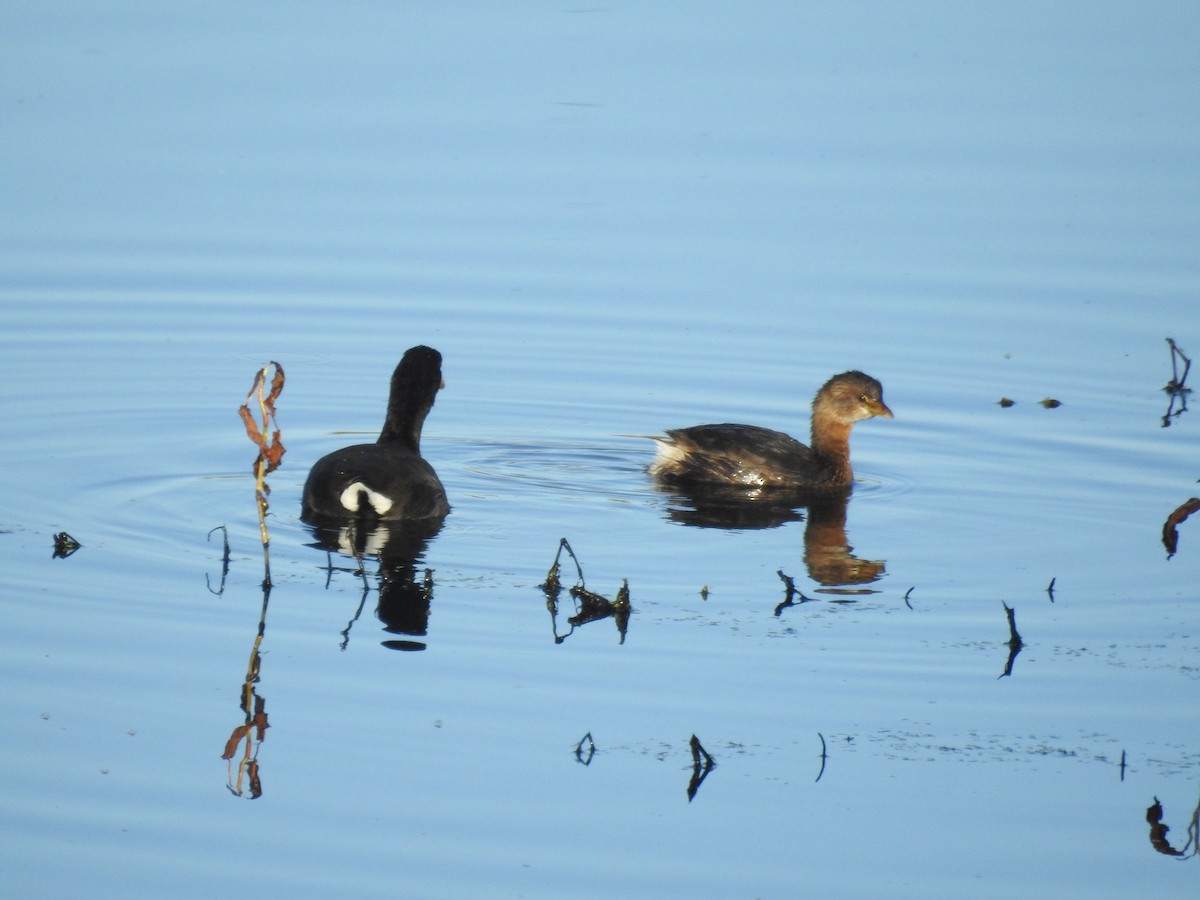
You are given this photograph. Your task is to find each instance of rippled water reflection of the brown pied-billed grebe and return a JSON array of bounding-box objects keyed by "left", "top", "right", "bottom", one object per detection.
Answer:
[{"left": 661, "top": 485, "right": 887, "bottom": 587}]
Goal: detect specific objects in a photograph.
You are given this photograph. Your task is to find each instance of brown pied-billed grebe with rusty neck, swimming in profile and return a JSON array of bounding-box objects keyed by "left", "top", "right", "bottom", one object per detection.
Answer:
[{"left": 649, "top": 372, "right": 892, "bottom": 491}]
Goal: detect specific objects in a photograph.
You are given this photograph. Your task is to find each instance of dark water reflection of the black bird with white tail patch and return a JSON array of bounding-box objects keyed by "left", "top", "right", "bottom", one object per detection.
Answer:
[{"left": 310, "top": 517, "right": 445, "bottom": 650}]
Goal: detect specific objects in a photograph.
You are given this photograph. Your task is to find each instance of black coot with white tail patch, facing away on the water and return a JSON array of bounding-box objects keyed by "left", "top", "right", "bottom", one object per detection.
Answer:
[{"left": 304, "top": 347, "right": 450, "bottom": 522}]
